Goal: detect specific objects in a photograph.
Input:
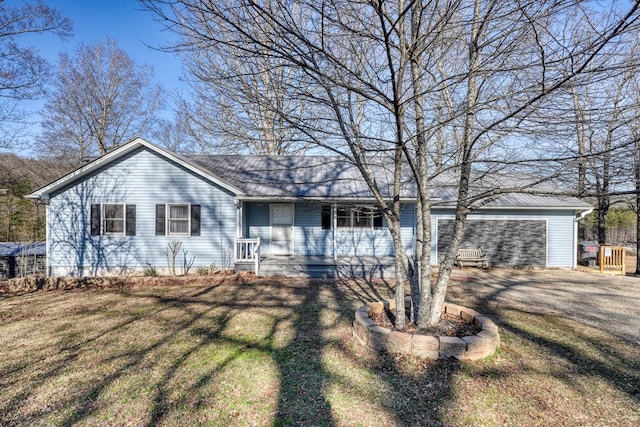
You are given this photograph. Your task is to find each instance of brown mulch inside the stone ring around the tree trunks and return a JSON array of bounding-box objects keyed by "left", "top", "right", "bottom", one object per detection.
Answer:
[{"left": 369, "top": 309, "right": 480, "bottom": 338}]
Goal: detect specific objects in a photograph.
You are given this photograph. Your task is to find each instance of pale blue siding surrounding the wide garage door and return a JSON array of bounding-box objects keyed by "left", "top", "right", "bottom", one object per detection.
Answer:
[{"left": 431, "top": 209, "right": 575, "bottom": 268}]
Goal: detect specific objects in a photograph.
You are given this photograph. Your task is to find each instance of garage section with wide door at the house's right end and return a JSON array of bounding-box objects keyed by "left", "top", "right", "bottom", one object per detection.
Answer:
[{"left": 432, "top": 194, "right": 590, "bottom": 268}]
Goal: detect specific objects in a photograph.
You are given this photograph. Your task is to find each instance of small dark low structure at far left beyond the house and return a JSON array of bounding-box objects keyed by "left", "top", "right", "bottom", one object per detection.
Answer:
[{"left": 0, "top": 242, "right": 47, "bottom": 280}]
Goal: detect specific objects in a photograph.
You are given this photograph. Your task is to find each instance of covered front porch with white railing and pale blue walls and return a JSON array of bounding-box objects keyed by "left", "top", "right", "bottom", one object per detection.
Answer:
[{"left": 234, "top": 200, "right": 413, "bottom": 278}]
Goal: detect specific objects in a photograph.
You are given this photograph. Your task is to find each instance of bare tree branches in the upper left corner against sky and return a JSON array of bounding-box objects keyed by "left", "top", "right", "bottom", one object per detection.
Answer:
[{"left": 0, "top": 1, "right": 72, "bottom": 148}]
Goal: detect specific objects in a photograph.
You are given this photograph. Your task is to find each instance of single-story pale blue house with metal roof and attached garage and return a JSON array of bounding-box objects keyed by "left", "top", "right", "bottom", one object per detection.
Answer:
[{"left": 28, "top": 138, "right": 591, "bottom": 276}]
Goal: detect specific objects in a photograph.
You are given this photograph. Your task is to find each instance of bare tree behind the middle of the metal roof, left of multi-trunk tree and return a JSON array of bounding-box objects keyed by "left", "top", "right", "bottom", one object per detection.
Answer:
[{"left": 148, "top": 2, "right": 309, "bottom": 155}]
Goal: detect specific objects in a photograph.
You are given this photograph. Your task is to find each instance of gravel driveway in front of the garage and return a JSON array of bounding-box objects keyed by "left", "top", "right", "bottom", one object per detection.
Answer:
[{"left": 452, "top": 269, "right": 640, "bottom": 345}]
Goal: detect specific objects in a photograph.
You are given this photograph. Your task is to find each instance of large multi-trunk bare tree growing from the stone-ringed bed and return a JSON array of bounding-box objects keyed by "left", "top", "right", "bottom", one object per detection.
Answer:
[{"left": 144, "top": 0, "right": 638, "bottom": 328}]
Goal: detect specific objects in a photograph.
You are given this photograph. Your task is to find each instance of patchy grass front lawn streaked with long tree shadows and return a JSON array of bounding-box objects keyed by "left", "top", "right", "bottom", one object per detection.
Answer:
[{"left": 0, "top": 277, "right": 640, "bottom": 426}]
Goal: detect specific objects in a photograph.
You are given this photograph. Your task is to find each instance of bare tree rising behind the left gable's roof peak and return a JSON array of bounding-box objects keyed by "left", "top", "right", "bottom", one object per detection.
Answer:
[{"left": 41, "top": 40, "right": 164, "bottom": 166}]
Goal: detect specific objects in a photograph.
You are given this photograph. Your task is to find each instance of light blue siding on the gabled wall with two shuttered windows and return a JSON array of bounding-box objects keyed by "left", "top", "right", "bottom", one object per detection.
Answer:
[{"left": 48, "top": 148, "right": 236, "bottom": 275}]
